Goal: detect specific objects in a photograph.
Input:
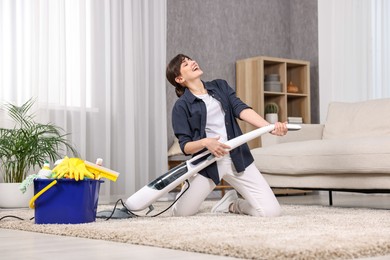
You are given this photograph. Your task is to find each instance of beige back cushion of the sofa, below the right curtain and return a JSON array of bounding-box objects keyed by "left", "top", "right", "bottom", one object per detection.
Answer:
[{"left": 322, "top": 98, "right": 390, "bottom": 139}]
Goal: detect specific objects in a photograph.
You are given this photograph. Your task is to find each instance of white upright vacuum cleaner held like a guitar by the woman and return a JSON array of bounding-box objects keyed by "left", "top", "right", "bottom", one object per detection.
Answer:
[{"left": 125, "top": 124, "right": 301, "bottom": 211}]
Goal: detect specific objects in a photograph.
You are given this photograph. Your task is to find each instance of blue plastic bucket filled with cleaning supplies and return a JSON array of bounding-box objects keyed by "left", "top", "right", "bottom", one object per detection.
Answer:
[{"left": 34, "top": 179, "right": 103, "bottom": 224}]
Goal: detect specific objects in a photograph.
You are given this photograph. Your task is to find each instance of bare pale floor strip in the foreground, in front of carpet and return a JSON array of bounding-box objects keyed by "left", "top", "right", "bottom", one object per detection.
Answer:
[{"left": 0, "top": 229, "right": 231, "bottom": 260}]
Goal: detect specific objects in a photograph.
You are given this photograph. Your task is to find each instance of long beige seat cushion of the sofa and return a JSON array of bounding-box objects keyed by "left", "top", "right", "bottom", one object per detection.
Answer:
[{"left": 252, "top": 136, "right": 390, "bottom": 177}]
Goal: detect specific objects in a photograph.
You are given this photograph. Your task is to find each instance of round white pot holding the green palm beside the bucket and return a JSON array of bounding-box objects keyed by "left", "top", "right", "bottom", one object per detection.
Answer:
[{"left": 0, "top": 183, "right": 34, "bottom": 208}]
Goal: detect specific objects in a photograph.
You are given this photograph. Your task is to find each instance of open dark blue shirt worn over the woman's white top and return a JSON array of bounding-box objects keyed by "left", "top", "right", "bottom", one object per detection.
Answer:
[{"left": 172, "top": 79, "right": 254, "bottom": 185}]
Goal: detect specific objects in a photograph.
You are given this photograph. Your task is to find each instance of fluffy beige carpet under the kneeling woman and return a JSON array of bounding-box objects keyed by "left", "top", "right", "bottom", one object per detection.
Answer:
[{"left": 0, "top": 202, "right": 390, "bottom": 259}]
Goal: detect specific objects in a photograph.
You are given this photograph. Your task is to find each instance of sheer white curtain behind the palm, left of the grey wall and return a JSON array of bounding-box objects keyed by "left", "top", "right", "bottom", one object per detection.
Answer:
[{"left": 0, "top": 0, "right": 167, "bottom": 202}]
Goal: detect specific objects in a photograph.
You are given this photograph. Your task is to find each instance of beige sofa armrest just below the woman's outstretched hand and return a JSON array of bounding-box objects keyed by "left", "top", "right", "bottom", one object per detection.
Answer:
[{"left": 261, "top": 124, "right": 324, "bottom": 147}]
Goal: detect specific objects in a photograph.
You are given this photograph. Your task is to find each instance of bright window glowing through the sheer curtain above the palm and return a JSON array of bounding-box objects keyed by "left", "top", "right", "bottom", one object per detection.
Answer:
[{"left": 0, "top": 0, "right": 92, "bottom": 107}]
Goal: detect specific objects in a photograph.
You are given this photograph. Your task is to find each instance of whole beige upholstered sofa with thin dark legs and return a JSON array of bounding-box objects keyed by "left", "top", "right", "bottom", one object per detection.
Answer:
[{"left": 252, "top": 99, "right": 390, "bottom": 204}]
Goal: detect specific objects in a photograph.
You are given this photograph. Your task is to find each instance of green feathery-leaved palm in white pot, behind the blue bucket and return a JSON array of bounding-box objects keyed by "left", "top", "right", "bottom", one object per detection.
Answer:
[{"left": 0, "top": 99, "right": 78, "bottom": 207}]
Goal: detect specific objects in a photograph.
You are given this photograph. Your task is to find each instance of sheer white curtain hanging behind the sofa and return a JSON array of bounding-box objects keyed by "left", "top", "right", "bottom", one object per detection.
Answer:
[{"left": 318, "top": 0, "right": 390, "bottom": 122}]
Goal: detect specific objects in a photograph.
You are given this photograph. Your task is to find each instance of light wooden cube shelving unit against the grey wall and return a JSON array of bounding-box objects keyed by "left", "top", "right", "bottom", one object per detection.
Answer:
[{"left": 236, "top": 56, "right": 310, "bottom": 149}]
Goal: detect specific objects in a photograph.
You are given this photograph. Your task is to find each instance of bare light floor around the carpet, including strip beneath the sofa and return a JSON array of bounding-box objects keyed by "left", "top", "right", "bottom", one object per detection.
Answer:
[{"left": 0, "top": 192, "right": 390, "bottom": 260}]
